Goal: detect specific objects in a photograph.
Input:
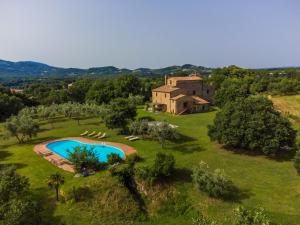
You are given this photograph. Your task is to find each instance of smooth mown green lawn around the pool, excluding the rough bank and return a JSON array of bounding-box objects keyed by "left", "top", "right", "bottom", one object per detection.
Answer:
[{"left": 0, "top": 110, "right": 300, "bottom": 225}]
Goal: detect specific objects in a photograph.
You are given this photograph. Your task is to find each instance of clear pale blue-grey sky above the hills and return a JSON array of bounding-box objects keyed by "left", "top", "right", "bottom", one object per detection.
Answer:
[{"left": 0, "top": 0, "right": 300, "bottom": 69}]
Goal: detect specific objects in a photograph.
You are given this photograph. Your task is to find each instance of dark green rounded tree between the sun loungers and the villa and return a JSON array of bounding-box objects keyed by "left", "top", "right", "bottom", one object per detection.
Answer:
[{"left": 102, "top": 98, "right": 136, "bottom": 130}]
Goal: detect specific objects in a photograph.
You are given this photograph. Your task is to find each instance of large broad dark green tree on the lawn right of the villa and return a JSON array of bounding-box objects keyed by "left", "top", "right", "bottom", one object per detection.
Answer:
[{"left": 208, "top": 97, "right": 296, "bottom": 155}]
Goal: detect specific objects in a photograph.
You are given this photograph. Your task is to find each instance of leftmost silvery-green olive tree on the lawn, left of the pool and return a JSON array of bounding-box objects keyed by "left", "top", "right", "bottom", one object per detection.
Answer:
[{"left": 4, "top": 113, "right": 39, "bottom": 143}]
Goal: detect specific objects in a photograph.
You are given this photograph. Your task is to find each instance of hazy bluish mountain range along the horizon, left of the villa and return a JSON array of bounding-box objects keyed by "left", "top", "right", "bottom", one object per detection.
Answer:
[{"left": 0, "top": 60, "right": 211, "bottom": 78}]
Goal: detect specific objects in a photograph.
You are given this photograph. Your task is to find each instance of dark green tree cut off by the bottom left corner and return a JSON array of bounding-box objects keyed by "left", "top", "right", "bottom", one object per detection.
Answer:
[{"left": 0, "top": 166, "right": 42, "bottom": 225}]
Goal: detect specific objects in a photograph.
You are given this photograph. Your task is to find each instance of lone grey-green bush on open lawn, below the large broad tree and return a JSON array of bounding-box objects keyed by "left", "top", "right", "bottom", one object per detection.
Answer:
[{"left": 192, "top": 161, "right": 234, "bottom": 198}]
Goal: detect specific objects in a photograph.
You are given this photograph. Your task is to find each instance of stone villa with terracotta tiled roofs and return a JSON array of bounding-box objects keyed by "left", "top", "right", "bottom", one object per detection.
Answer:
[{"left": 152, "top": 75, "right": 213, "bottom": 115}]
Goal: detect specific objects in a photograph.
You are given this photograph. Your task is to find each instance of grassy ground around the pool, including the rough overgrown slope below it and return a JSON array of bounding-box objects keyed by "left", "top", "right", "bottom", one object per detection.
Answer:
[{"left": 0, "top": 105, "right": 300, "bottom": 224}]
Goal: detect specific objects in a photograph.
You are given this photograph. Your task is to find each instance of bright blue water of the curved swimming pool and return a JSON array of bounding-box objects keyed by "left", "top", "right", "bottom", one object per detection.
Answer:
[{"left": 47, "top": 140, "right": 125, "bottom": 162}]
